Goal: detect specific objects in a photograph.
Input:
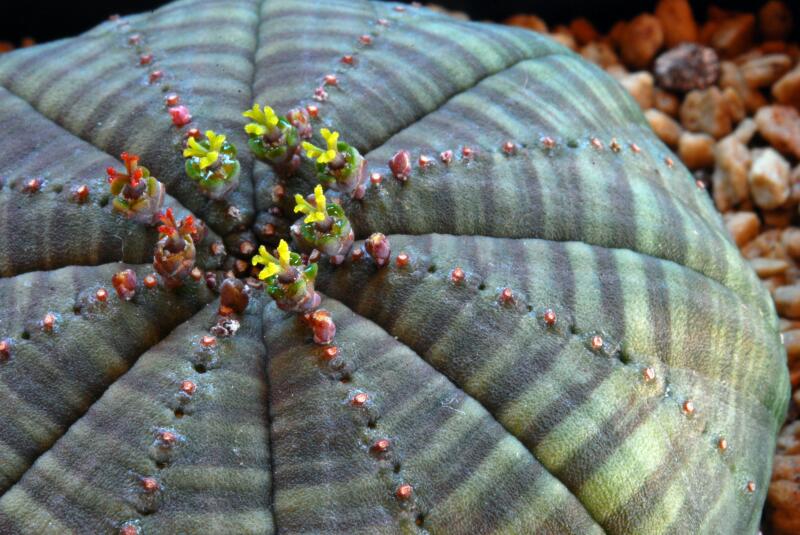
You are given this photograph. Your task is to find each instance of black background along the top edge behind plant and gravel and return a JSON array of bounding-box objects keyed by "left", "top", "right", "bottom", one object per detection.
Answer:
[{"left": 0, "top": 0, "right": 800, "bottom": 43}]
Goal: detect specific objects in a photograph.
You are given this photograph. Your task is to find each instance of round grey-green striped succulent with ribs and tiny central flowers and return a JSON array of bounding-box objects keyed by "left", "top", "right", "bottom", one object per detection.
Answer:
[{"left": 0, "top": 0, "right": 788, "bottom": 535}]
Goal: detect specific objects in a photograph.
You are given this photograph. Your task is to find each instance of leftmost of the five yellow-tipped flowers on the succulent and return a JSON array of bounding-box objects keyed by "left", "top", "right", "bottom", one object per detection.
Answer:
[{"left": 183, "top": 130, "right": 240, "bottom": 199}]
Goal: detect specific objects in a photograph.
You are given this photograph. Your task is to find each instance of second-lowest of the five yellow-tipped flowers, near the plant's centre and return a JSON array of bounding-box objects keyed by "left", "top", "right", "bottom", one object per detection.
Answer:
[{"left": 290, "top": 184, "right": 354, "bottom": 264}]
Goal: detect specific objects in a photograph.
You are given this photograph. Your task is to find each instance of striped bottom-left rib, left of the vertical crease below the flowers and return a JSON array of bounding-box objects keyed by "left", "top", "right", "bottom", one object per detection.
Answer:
[{"left": 0, "top": 301, "right": 272, "bottom": 534}]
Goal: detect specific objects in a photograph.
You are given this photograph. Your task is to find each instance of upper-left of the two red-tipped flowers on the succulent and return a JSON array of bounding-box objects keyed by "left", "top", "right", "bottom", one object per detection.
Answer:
[{"left": 106, "top": 152, "right": 165, "bottom": 224}]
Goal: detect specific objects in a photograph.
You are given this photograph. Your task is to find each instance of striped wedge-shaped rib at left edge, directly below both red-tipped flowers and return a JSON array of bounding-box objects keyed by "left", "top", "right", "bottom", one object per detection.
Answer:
[{"left": 0, "top": 263, "right": 213, "bottom": 494}]
